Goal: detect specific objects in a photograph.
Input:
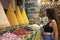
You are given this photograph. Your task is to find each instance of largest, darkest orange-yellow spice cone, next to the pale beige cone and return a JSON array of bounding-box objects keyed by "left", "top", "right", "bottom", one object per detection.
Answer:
[{"left": 6, "top": 4, "right": 19, "bottom": 26}]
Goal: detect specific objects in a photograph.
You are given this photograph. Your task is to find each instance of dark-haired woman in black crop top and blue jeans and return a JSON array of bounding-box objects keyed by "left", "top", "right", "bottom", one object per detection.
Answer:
[{"left": 43, "top": 8, "right": 58, "bottom": 40}]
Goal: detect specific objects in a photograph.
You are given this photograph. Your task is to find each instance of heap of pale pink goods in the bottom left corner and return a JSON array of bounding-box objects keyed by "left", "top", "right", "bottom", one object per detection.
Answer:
[{"left": 0, "top": 33, "right": 21, "bottom": 40}]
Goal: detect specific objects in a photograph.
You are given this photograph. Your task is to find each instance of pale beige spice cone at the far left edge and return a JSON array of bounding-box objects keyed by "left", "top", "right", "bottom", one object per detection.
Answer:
[{"left": 0, "top": 2, "right": 10, "bottom": 28}]
